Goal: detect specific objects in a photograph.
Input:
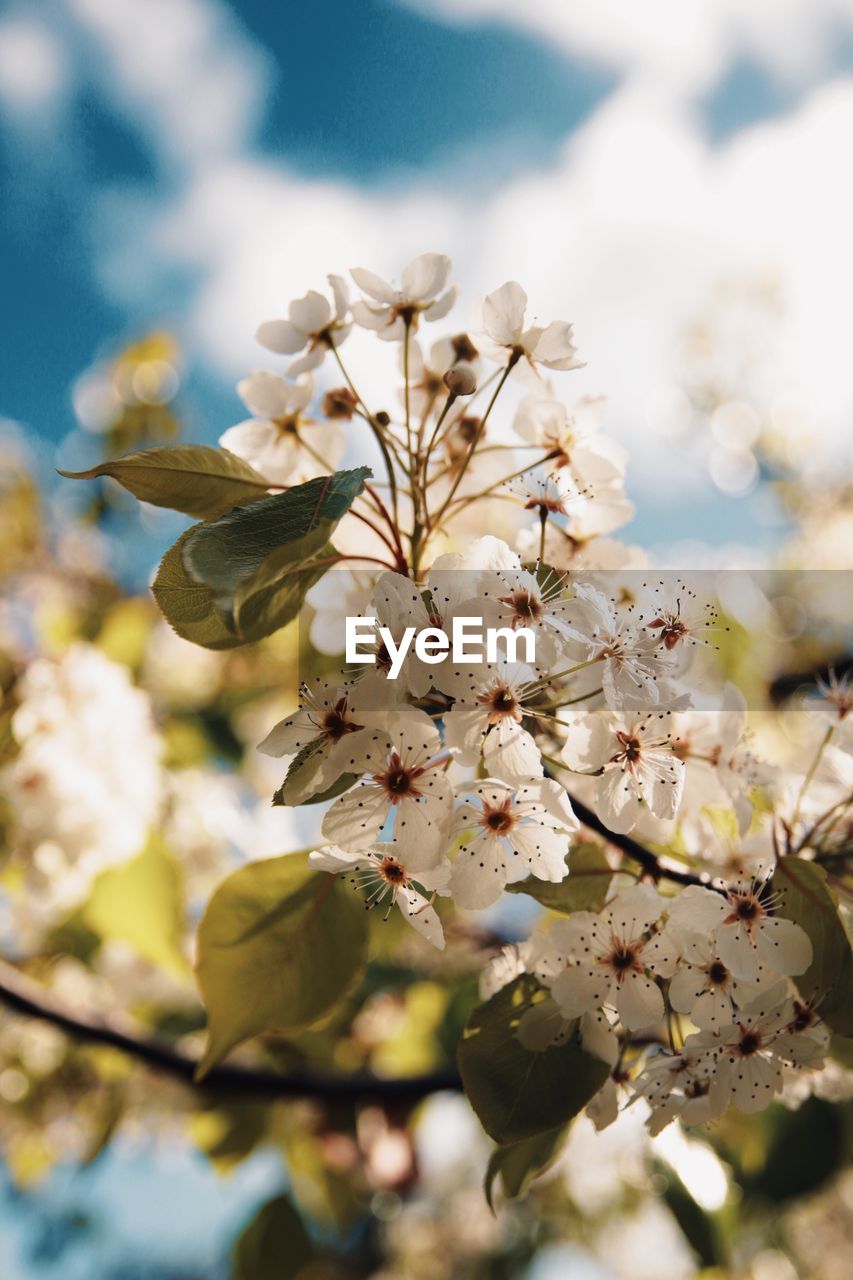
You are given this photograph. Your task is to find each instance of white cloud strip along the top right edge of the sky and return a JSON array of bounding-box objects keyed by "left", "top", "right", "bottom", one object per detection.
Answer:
[{"left": 401, "top": 0, "right": 853, "bottom": 96}]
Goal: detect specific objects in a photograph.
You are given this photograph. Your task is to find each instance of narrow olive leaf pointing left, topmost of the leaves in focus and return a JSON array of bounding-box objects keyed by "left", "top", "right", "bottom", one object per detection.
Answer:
[{"left": 59, "top": 444, "right": 269, "bottom": 520}]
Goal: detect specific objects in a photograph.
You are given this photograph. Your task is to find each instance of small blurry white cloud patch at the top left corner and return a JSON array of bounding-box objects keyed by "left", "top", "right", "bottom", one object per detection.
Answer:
[{"left": 0, "top": 14, "right": 67, "bottom": 118}]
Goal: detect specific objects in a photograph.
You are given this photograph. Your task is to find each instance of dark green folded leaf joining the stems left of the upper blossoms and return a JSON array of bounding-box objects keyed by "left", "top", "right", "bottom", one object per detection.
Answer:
[{"left": 182, "top": 467, "right": 370, "bottom": 629}]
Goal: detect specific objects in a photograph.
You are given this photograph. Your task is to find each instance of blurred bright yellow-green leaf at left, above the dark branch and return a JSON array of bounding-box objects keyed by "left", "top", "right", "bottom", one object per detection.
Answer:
[{"left": 81, "top": 836, "right": 190, "bottom": 978}]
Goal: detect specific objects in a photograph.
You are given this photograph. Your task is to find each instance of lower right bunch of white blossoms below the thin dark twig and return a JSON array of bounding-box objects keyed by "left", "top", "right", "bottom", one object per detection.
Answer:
[{"left": 507, "top": 883, "right": 830, "bottom": 1133}]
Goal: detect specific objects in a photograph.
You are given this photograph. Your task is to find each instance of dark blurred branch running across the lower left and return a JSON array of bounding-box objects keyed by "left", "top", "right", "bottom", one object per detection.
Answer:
[{"left": 0, "top": 960, "right": 462, "bottom": 1103}]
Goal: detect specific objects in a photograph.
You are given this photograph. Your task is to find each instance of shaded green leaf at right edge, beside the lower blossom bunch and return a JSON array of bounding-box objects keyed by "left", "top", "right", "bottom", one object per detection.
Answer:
[{"left": 772, "top": 858, "right": 853, "bottom": 1036}]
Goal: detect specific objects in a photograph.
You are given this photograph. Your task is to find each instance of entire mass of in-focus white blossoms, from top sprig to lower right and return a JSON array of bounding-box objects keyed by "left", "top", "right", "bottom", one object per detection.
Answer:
[{"left": 230, "top": 255, "right": 850, "bottom": 1130}]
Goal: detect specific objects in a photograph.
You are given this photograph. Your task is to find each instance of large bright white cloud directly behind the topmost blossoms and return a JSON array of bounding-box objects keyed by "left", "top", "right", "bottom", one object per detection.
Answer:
[{"left": 116, "top": 72, "right": 853, "bottom": 506}]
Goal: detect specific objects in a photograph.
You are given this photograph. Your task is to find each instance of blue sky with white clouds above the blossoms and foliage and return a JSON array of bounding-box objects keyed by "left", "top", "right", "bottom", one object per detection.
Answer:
[{"left": 0, "top": 0, "right": 853, "bottom": 570}]
